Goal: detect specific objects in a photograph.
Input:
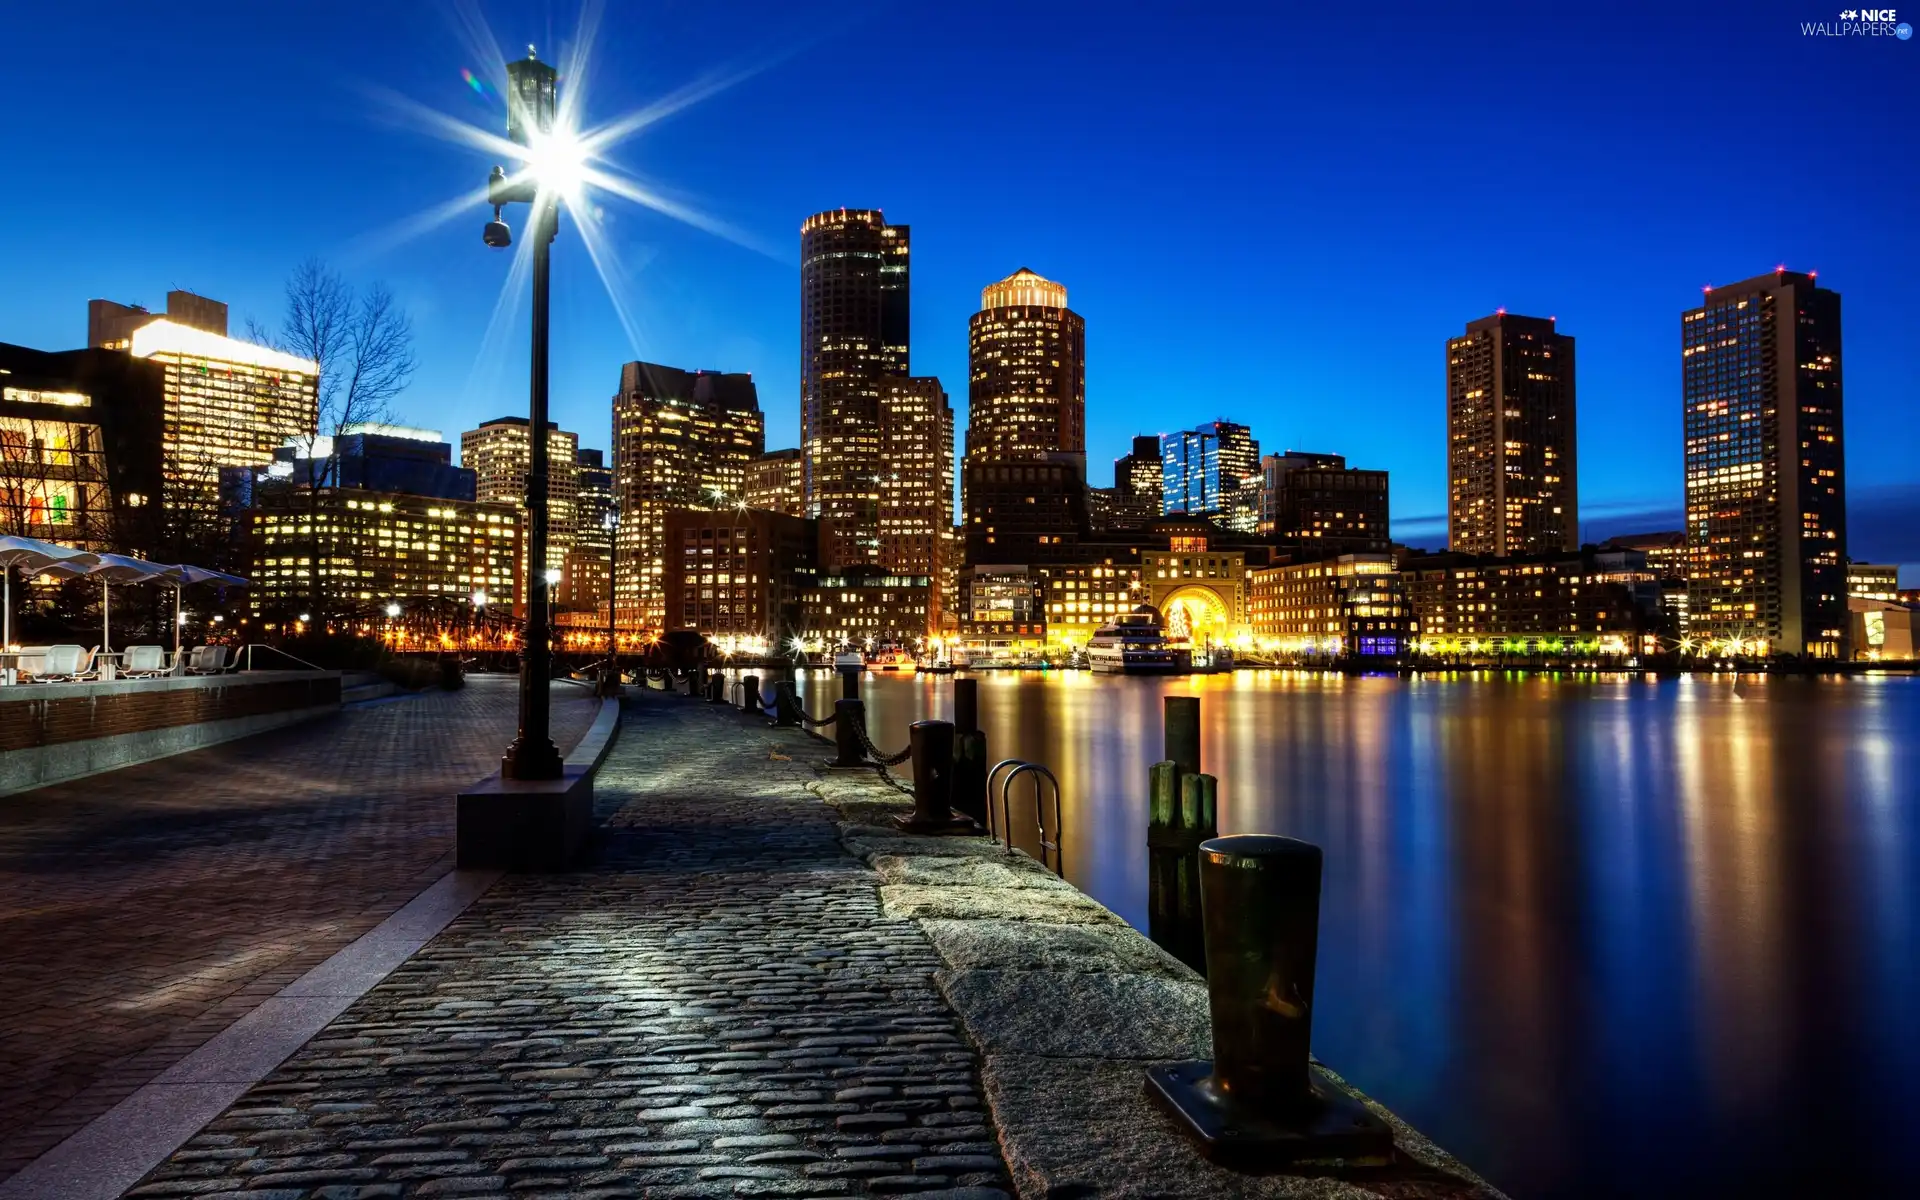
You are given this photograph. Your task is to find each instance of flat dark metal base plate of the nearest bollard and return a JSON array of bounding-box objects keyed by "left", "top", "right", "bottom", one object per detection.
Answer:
[{"left": 1146, "top": 1062, "right": 1394, "bottom": 1169}]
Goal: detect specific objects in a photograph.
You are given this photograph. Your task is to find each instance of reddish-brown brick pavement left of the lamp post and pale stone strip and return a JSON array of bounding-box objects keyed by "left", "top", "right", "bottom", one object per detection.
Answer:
[{"left": 0, "top": 676, "right": 595, "bottom": 1179}]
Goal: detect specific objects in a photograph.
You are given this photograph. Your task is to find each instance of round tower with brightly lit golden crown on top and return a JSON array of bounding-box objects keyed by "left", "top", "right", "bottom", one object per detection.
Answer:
[{"left": 966, "top": 267, "right": 1087, "bottom": 463}]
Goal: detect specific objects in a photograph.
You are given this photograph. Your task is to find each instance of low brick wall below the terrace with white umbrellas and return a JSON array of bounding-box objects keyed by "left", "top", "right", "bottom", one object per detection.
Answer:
[{"left": 0, "top": 670, "right": 340, "bottom": 795}]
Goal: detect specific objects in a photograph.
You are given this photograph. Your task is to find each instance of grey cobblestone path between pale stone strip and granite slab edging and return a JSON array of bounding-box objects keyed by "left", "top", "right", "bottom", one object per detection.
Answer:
[{"left": 129, "top": 683, "right": 1006, "bottom": 1200}]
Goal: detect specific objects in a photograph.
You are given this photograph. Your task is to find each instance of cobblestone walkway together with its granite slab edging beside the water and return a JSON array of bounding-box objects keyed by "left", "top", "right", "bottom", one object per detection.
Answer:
[{"left": 0, "top": 679, "right": 1492, "bottom": 1200}]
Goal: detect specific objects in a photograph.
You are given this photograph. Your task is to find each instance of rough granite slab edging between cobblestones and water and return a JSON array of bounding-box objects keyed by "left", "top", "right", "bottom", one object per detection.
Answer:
[{"left": 810, "top": 770, "right": 1500, "bottom": 1200}]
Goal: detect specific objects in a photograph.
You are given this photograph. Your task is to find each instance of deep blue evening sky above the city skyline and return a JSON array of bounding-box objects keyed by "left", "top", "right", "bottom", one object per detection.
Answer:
[{"left": 11, "top": 0, "right": 1920, "bottom": 564}]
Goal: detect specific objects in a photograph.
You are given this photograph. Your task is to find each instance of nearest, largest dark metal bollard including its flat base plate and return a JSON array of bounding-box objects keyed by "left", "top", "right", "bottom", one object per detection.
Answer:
[{"left": 1146, "top": 833, "right": 1394, "bottom": 1167}]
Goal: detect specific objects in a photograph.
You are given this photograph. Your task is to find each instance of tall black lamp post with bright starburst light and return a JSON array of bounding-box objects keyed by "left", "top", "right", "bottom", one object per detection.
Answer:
[{"left": 482, "top": 46, "right": 561, "bottom": 780}]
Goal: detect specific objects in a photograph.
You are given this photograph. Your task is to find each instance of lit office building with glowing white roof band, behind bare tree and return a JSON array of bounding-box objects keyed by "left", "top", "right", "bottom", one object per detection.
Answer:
[{"left": 127, "top": 319, "right": 319, "bottom": 536}]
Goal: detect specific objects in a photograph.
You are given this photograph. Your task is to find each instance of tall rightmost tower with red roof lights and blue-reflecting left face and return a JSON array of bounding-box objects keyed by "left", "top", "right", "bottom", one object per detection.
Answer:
[{"left": 1680, "top": 269, "right": 1847, "bottom": 659}]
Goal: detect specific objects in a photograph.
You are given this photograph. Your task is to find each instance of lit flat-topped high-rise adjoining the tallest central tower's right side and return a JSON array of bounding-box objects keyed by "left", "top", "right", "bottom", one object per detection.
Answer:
[{"left": 879, "top": 376, "right": 954, "bottom": 632}]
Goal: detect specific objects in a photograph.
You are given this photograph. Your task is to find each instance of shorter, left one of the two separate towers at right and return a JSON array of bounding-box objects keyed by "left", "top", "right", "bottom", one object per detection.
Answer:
[{"left": 1446, "top": 311, "right": 1580, "bottom": 555}]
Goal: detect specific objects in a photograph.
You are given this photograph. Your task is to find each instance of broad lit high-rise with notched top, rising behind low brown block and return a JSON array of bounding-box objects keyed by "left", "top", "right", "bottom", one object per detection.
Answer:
[{"left": 612, "top": 363, "right": 764, "bottom": 628}]
